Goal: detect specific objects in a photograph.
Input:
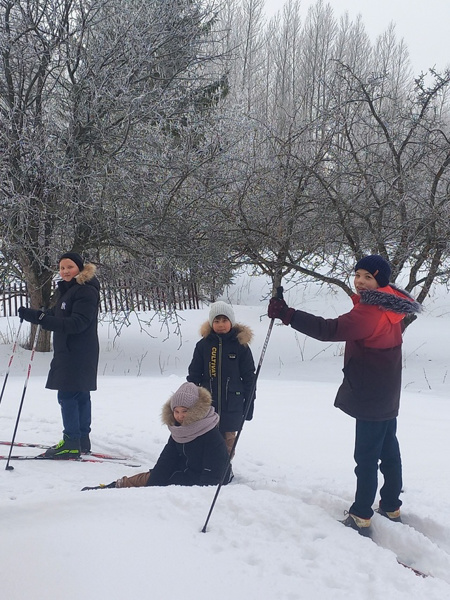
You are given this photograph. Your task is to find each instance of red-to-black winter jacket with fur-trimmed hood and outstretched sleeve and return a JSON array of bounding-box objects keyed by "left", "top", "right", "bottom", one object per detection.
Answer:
[{"left": 290, "top": 285, "right": 420, "bottom": 421}]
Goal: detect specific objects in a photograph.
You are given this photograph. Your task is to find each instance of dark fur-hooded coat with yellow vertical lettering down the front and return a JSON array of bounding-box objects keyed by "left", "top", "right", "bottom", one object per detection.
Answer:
[{"left": 187, "top": 322, "right": 255, "bottom": 432}]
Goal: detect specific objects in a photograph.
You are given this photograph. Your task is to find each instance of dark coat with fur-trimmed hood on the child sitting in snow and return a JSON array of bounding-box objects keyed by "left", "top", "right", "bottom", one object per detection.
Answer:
[{"left": 147, "top": 388, "right": 229, "bottom": 486}]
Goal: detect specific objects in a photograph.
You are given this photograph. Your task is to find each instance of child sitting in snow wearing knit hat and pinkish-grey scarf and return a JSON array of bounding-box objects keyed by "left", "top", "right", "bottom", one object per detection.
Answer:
[{"left": 83, "top": 383, "right": 229, "bottom": 490}]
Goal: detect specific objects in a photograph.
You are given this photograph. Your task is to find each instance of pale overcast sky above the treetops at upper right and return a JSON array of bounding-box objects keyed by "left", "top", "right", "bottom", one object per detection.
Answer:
[{"left": 266, "top": 0, "right": 450, "bottom": 75}]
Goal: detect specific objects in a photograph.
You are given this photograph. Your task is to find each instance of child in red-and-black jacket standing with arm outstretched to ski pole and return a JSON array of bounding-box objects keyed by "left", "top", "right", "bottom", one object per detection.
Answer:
[{"left": 268, "top": 254, "right": 421, "bottom": 535}]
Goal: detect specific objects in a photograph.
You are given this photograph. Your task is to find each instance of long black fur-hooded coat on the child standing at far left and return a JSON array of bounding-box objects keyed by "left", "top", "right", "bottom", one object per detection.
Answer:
[{"left": 39, "top": 263, "right": 100, "bottom": 392}]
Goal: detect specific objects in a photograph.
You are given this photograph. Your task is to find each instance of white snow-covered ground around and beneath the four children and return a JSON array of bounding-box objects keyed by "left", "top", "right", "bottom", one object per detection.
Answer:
[{"left": 0, "top": 278, "right": 450, "bottom": 600}]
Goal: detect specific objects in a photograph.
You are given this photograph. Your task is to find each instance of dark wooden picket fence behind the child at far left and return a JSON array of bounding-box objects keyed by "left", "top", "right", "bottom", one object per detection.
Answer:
[{"left": 0, "top": 282, "right": 200, "bottom": 317}]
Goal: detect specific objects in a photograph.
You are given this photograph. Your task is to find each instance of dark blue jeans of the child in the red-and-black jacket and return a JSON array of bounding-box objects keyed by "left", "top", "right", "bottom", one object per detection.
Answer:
[{"left": 349, "top": 419, "right": 402, "bottom": 519}]
